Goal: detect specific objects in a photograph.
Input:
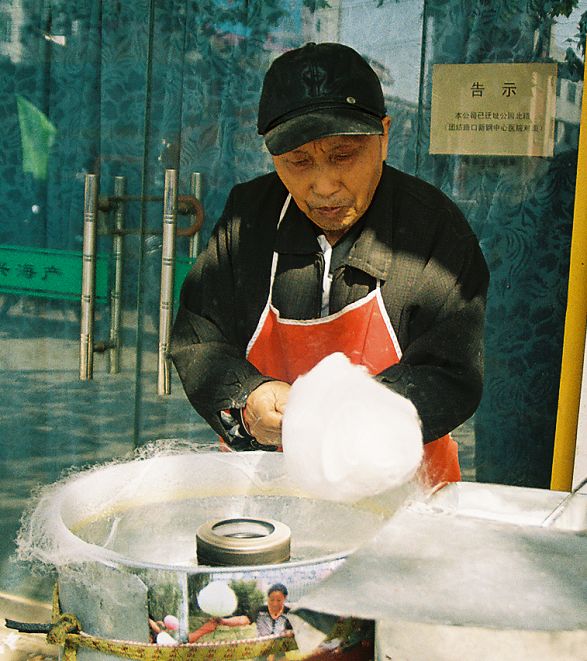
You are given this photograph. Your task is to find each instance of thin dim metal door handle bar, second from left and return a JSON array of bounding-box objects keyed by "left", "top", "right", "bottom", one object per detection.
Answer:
[{"left": 109, "top": 177, "right": 126, "bottom": 374}]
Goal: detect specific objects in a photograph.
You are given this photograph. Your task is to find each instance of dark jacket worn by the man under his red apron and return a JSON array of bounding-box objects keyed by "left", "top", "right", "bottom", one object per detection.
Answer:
[{"left": 172, "top": 166, "right": 489, "bottom": 442}]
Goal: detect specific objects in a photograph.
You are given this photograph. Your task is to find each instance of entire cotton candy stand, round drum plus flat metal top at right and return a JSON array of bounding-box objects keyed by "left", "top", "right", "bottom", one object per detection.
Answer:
[{"left": 14, "top": 448, "right": 587, "bottom": 661}]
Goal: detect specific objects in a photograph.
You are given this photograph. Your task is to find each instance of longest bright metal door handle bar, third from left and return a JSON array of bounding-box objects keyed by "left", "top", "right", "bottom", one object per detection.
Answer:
[{"left": 157, "top": 170, "right": 177, "bottom": 395}]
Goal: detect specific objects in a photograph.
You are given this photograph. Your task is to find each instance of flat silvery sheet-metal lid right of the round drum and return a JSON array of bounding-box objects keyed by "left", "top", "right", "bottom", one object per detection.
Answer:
[{"left": 297, "top": 509, "right": 587, "bottom": 632}]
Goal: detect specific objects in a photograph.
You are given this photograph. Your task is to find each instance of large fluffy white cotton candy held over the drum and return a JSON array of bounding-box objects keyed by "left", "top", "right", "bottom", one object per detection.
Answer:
[{"left": 282, "top": 353, "right": 423, "bottom": 502}]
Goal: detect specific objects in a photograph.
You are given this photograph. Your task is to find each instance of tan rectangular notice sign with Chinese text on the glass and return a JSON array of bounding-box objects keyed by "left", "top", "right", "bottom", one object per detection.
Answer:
[{"left": 430, "top": 63, "right": 557, "bottom": 156}]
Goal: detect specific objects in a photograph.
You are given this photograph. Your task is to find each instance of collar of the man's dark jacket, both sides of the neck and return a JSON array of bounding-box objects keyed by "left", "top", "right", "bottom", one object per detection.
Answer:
[{"left": 275, "top": 165, "right": 392, "bottom": 280}]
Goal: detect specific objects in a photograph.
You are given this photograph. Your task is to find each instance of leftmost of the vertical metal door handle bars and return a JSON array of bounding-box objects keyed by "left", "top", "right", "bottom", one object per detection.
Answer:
[{"left": 80, "top": 174, "right": 99, "bottom": 381}]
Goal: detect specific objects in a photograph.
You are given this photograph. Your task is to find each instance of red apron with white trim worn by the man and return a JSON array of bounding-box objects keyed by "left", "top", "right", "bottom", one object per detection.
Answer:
[{"left": 247, "top": 196, "right": 461, "bottom": 486}]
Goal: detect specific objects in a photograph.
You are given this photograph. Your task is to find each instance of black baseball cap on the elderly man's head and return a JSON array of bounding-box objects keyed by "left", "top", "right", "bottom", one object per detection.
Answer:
[{"left": 257, "top": 43, "right": 386, "bottom": 156}]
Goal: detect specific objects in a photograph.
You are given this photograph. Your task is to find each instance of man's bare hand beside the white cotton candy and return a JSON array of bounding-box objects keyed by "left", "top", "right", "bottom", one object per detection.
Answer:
[{"left": 244, "top": 381, "right": 291, "bottom": 445}]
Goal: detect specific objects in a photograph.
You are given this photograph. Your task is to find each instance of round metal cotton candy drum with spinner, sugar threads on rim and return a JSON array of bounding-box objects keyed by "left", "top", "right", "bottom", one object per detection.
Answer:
[{"left": 19, "top": 450, "right": 413, "bottom": 661}]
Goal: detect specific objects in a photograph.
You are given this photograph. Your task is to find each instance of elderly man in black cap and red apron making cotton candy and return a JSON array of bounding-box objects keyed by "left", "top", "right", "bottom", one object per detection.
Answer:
[{"left": 172, "top": 43, "right": 488, "bottom": 483}]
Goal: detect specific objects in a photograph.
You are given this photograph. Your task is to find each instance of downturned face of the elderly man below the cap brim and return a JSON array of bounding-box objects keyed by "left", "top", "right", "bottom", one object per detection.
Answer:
[{"left": 273, "top": 117, "right": 390, "bottom": 243}]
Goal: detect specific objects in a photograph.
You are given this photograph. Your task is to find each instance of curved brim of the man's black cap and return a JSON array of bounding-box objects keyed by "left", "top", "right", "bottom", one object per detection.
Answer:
[{"left": 264, "top": 108, "right": 383, "bottom": 156}]
